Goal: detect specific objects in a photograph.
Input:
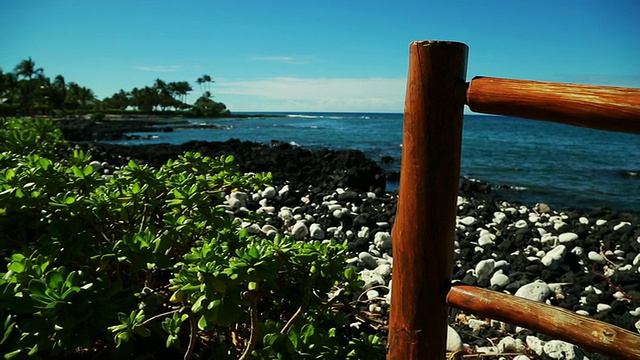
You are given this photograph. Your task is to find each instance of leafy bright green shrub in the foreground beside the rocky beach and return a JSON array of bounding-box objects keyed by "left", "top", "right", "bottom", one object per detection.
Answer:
[{"left": 0, "top": 120, "right": 385, "bottom": 359}]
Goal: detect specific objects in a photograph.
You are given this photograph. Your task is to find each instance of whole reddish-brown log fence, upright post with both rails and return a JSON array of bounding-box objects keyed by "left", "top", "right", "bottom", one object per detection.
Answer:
[{"left": 388, "top": 41, "right": 640, "bottom": 360}]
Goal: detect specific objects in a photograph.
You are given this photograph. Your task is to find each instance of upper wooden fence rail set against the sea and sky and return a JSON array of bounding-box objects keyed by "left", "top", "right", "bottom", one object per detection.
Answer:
[{"left": 466, "top": 77, "right": 640, "bottom": 134}]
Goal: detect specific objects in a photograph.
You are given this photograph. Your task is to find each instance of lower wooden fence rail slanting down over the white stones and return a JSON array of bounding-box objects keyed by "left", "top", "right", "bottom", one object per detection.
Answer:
[{"left": 447, "top": 285, "right": 640, "bottom": 360}]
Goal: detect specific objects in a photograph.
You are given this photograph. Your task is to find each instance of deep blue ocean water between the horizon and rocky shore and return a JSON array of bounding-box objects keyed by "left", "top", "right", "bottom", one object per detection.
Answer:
[{"left": 111, "top": 113, "right": 640, "bottom": 214}]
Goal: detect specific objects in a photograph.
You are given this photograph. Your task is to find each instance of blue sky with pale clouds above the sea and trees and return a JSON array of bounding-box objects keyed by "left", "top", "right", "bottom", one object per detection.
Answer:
[{"left": 0, "top": 0, "right": 640, "bottom": 112}]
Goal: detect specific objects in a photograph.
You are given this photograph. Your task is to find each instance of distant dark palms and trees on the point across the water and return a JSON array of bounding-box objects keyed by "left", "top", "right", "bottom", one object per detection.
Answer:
[{"left": 0, "top": 58, "right": 229, "bottom": 117}]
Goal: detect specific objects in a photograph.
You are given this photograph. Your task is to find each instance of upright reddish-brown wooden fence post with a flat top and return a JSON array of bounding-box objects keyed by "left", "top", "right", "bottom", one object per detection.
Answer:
[{"left": 388, "top": 41, "right": 468, "bottom": 360}]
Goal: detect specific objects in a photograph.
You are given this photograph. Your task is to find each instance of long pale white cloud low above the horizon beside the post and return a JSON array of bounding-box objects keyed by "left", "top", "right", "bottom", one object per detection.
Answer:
[{"left": 214, "top": 77, "right": 406, "bottom": 112}]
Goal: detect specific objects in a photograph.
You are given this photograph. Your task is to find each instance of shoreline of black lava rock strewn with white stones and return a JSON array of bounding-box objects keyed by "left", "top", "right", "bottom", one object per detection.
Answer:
[{"left": 57, "top": 119, "right": 640, "bottom": 360}]
